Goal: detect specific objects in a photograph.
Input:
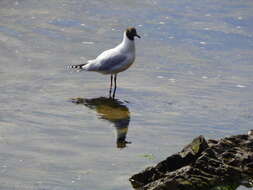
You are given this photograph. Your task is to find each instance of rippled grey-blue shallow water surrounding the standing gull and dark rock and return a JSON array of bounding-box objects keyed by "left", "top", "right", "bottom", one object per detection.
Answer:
[{"left": 0, "top": 0, "right": 253, "bottom": 190}]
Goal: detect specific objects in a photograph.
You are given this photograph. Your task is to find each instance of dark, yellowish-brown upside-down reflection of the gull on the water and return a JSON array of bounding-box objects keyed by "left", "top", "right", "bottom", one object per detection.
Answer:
[{"left": 72, "top": 97, "right": 131, "bottom": 148}]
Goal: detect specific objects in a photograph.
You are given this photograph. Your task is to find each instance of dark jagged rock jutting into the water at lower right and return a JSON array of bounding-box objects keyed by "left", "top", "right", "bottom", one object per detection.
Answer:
[{"left": 130, "top": 134, "right": 253, "bottom": 190}]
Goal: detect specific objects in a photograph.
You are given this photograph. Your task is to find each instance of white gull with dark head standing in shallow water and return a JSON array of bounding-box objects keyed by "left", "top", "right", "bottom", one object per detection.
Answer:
[{"left": 69, "top": 27, "right": 141, "bottom": 99}]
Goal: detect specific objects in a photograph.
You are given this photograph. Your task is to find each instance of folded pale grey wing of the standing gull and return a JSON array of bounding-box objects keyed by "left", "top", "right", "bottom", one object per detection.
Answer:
[{"left": 99, "top": 54, "right": 127, "bottom": 71}]
